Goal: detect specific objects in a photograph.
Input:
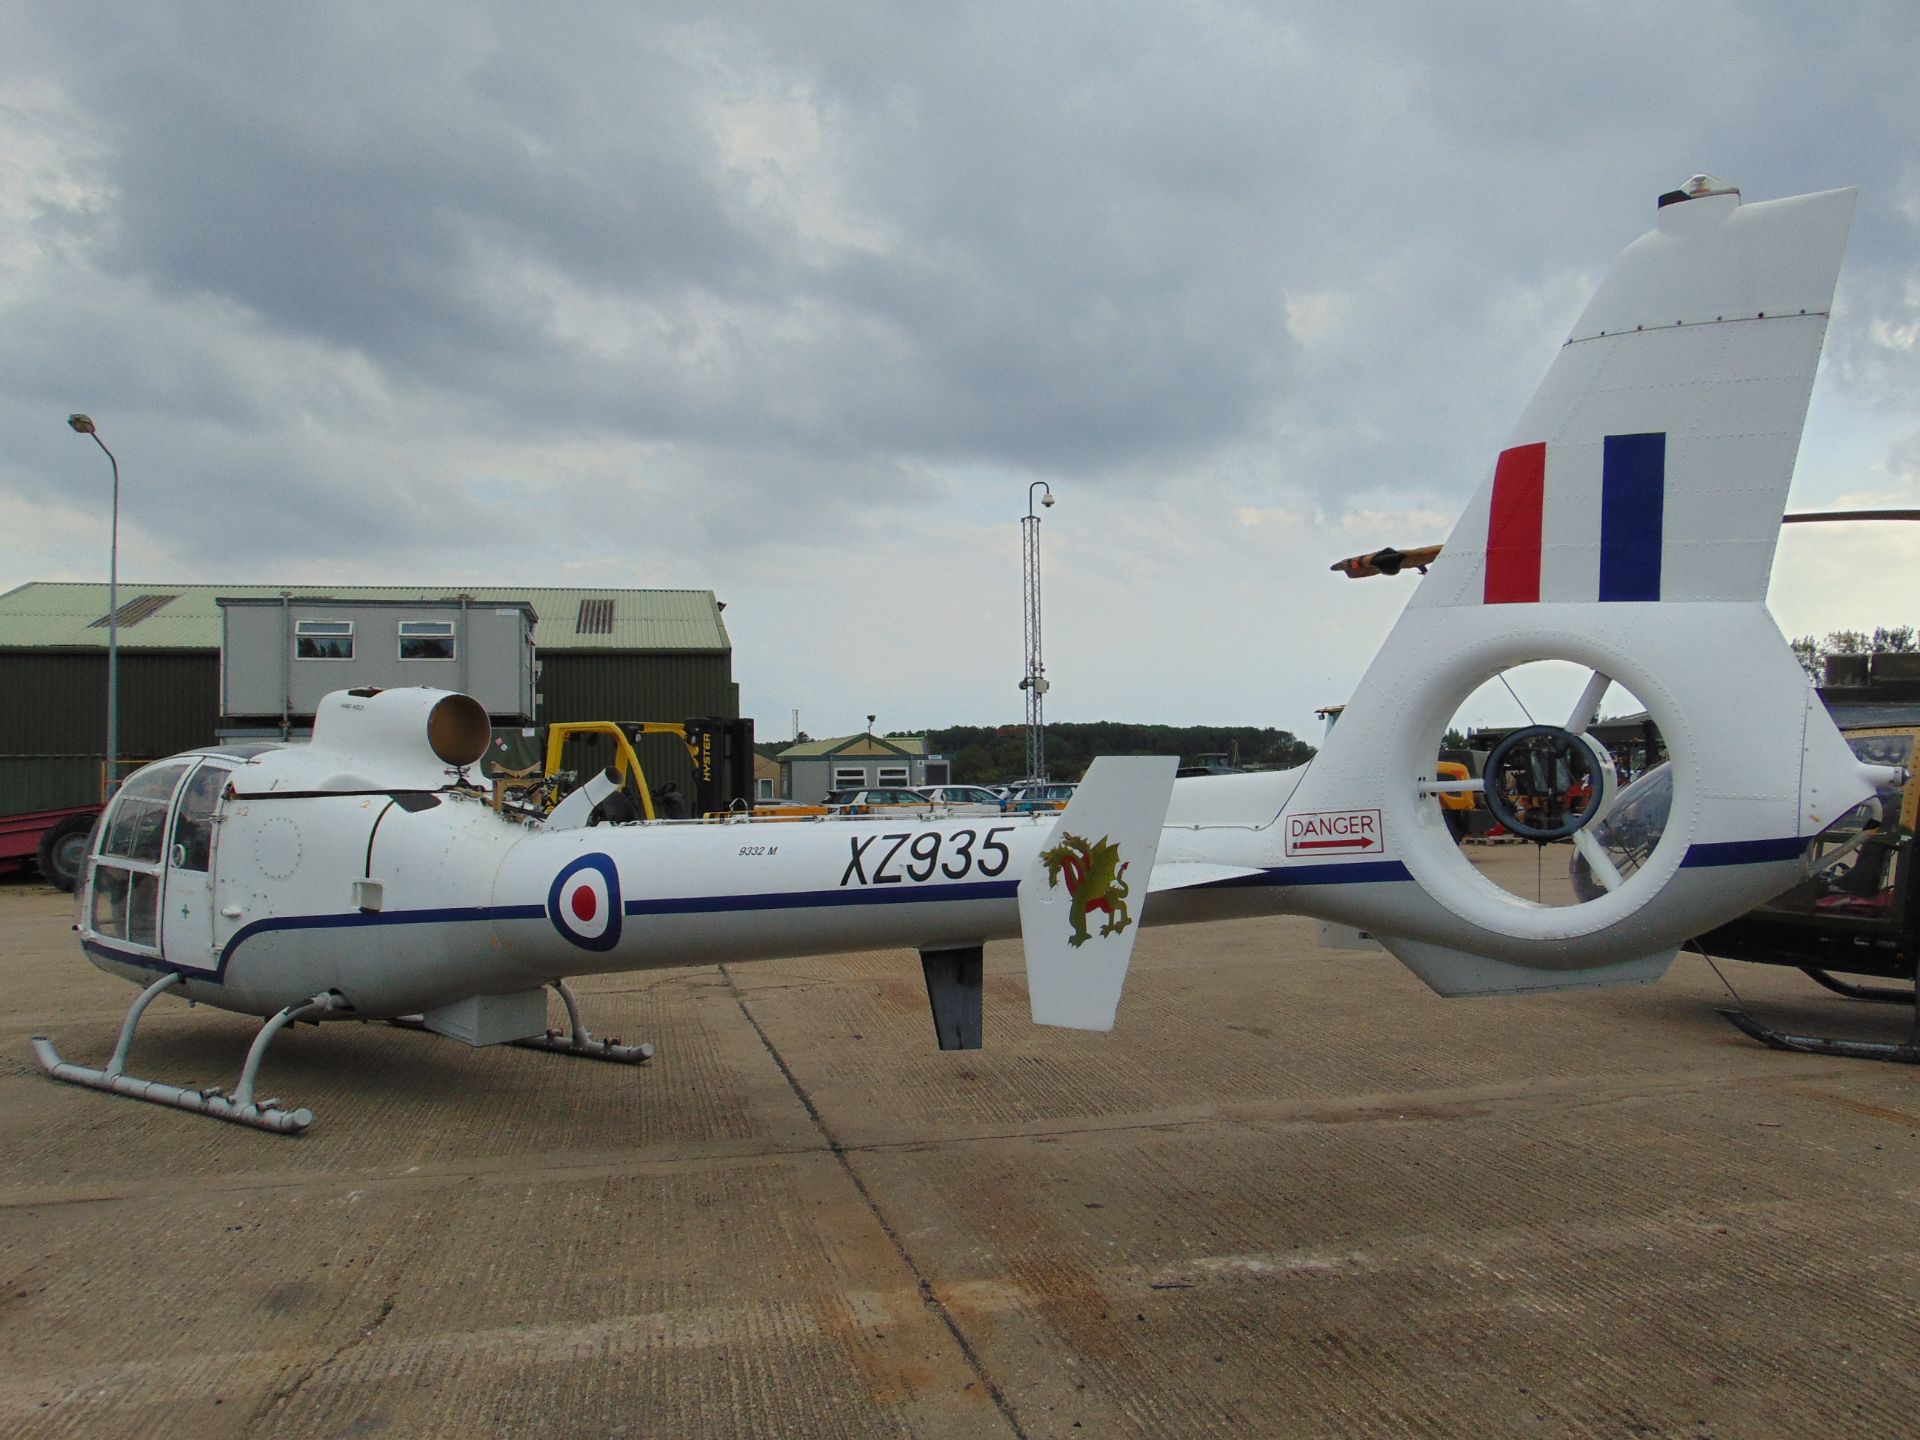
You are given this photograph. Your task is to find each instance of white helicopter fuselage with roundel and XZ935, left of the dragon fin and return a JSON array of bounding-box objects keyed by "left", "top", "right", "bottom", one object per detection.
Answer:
[{"left": 83, "top": 749, "right": 1058, "bottom": 1018}]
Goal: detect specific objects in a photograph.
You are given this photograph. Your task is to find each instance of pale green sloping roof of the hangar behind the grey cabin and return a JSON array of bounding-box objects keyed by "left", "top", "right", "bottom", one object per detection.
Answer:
[{"left": 0, "top": 580, "right": 733, "bottom": 653}]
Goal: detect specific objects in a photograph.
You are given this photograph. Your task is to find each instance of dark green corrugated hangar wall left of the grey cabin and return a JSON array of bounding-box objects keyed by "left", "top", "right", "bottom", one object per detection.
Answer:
[{"left": 0, "top": 651, "right": 221, "bottom": 814}]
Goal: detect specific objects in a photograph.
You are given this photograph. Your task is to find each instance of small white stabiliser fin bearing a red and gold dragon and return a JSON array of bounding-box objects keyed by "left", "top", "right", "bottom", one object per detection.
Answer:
[{"left": 1020, "top": 755, "right": 1179, "bottom": 1029}]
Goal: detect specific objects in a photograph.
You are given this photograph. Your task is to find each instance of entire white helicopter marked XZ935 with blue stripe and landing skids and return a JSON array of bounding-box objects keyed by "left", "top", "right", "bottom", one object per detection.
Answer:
[{"left": 35, "top": 177, "right": 1874, "bottom": 1131}]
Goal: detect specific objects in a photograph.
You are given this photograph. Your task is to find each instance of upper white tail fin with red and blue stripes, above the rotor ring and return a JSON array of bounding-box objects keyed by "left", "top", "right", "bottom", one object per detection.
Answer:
[{"left": 1413, "top": 190, "right": 1853, "bottom": 607}]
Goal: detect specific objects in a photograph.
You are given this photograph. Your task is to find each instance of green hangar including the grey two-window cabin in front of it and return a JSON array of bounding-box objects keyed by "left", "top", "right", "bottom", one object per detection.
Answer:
[{"left": 0, "top": 582, "right": 739, "bottom": 814}]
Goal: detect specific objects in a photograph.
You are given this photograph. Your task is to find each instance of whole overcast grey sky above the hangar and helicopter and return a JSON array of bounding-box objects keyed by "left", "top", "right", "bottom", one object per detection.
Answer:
[{"left": 0, "top": 11, "right": 1920, "bottom": 737}]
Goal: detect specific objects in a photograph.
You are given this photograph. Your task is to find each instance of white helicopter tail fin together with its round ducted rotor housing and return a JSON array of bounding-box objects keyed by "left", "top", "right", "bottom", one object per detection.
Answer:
[{"left": 1275, "top": 180, "right": 1872, "bottom": 993}]
